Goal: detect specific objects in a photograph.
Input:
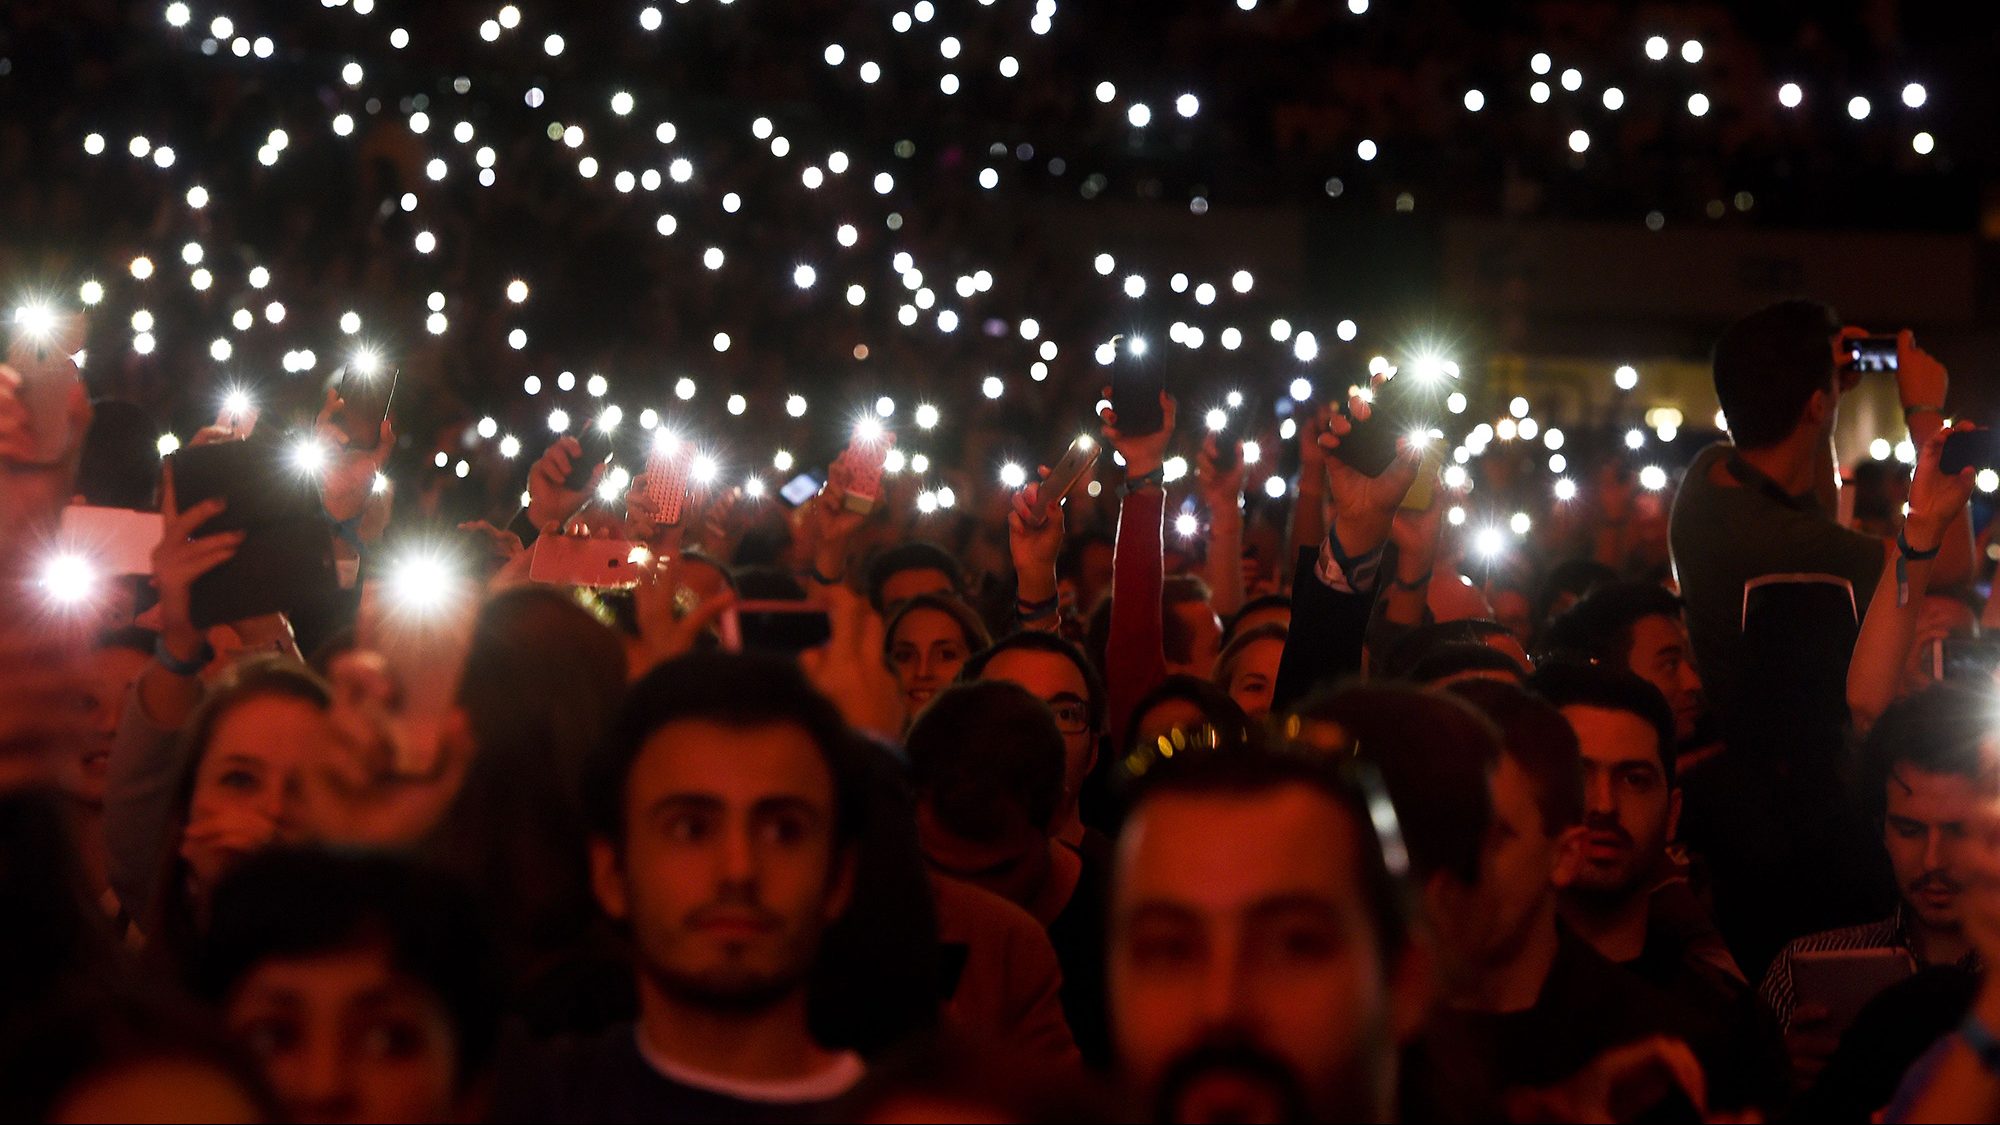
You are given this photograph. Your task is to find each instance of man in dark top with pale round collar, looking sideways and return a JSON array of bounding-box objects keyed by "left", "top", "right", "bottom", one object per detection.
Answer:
[{"left": 496, "top": 655, "right": 864, "bottom": 1121}]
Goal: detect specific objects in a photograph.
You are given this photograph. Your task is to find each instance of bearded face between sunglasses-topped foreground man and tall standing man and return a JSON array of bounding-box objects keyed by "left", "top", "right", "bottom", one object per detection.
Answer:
[{"left": 1562, "top": 707, "right": 1680, "bottom": 897}]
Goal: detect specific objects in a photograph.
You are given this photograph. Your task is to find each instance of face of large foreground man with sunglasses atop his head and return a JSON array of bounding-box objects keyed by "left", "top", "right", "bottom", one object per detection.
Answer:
[{"left": 1110, "top": 787, "right": 1420, "bottom": 1121}]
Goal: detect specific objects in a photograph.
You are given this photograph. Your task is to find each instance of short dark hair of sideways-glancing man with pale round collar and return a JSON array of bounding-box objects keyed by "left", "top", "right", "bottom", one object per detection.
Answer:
[{"left": 584, "top": 653, "right": 860, "bottom": 847}]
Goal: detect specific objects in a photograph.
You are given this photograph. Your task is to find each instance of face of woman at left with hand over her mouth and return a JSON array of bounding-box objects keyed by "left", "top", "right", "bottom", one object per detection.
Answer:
[{"left": 180, "top": 695, "right": 332, "bottom": 887}]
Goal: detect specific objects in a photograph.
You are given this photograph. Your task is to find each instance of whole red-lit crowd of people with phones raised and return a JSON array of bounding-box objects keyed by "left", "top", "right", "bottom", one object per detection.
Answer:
[{"left": 0, "top": 300, "right": 2000, "bottom": 1121}]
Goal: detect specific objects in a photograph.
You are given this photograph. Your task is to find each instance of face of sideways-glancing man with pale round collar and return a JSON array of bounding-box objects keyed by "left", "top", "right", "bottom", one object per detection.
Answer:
[{"left": 592, "top": 721, "right": 850, "bottom": 1009}]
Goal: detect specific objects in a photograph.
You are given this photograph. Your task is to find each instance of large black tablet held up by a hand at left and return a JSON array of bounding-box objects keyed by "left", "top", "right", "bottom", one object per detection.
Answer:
[{"left": 168, "top": 440, "right": 340, "bottom": 629}]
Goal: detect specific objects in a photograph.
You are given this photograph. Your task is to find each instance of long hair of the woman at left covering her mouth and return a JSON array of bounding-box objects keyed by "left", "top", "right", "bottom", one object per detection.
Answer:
[{"left": 146, "top": 657, "right": 334, "bottom": 967}]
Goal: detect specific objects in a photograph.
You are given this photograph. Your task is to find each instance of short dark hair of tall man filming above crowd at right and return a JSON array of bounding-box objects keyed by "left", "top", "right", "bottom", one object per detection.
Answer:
[{"left": 1714, "top": 300, "right": 1840, "bottom": 448}]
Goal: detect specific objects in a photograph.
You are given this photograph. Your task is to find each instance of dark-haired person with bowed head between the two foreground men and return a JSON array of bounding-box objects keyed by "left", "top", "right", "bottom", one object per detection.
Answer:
[{"left": 904, "top": 681, "right": 1110, "bottom": 1067}]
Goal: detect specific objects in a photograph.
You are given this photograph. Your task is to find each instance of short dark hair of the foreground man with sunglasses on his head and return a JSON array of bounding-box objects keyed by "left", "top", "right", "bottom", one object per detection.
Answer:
[{"left": 1130, "top": 745, "right": 1410, "bottom": 961}]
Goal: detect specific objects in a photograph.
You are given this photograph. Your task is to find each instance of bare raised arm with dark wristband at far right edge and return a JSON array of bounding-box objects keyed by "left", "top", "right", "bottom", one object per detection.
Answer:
[{"left": 1848, "top": 424, "right": 1972, "bottom": 735}]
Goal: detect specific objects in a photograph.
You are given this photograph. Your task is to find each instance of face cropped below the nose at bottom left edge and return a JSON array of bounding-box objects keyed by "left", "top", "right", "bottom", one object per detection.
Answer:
[{"left": 224, "top": 945, "right": 460, "bottom": 1121}]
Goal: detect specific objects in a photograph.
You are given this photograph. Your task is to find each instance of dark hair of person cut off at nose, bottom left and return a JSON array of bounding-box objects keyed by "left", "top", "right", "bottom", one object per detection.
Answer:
[{"left": 196, "top": 847, "right": 502, "bottom": 1085}]
